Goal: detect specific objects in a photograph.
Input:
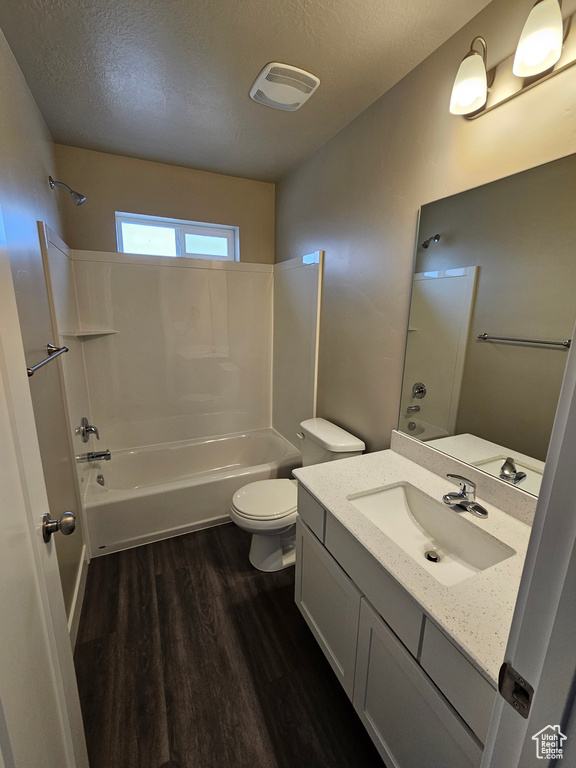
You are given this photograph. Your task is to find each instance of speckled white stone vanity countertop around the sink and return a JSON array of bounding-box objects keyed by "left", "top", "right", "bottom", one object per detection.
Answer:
[{"left": 294, "top": 450, "right": 530, "bottom": 687}]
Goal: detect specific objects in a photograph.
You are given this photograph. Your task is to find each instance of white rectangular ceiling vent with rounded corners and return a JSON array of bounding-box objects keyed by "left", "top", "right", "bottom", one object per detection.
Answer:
[{"left": 250, "top": 61, "right": 320, "bottom": 112}]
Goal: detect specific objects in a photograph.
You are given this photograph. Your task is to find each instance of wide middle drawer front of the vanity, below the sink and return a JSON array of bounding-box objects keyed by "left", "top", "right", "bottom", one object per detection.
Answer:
[{"left": 325, "top": 514, "right": 424, "bottom": 657}]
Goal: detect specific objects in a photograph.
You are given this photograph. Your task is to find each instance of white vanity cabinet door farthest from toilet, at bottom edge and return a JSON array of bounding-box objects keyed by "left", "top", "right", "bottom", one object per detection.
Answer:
[{"left": 354, "top": 599, "right": 482, "bottom": 768}]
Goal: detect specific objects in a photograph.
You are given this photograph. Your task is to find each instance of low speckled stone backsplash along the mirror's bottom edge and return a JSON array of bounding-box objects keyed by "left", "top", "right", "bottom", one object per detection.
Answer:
[{"left": 391, "top": 430, "right": 538, "bottom": 525}]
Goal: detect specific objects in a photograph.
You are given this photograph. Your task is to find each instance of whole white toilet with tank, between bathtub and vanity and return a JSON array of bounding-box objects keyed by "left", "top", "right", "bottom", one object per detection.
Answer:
[{"left": 230, "top": 419, "right": 366, "bottom": 572}]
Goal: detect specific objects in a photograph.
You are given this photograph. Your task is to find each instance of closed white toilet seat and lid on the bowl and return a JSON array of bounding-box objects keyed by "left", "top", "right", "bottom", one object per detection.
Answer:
[{"left": 232, "top": 479, "right": 298, "bottom": 520}]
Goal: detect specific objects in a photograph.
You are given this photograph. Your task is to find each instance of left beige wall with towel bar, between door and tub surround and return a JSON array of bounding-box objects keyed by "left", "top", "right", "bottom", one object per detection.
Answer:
[{"left": 0, "top": 32, "right": 82, "bottom": 609}]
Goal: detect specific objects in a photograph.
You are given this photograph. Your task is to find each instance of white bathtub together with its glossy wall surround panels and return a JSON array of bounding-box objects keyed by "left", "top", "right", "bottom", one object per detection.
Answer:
[{"left": 40, "top": 240, "right": 322, "bottom": 556}]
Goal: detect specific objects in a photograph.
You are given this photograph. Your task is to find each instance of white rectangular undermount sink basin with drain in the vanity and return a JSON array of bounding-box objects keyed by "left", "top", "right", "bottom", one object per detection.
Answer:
[{"left": 348, "top": 483, "right": 516, "bottom": 587}]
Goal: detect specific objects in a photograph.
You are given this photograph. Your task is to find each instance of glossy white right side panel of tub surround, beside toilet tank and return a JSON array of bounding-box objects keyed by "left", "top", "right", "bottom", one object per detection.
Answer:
[{"left": 272, "top": 251, "right": 324, "bottom": 445}]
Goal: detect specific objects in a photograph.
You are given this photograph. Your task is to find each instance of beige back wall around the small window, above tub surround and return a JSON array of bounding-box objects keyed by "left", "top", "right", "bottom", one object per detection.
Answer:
[{"left": 56, "top": 144, "right": 274, "bottom": 264}]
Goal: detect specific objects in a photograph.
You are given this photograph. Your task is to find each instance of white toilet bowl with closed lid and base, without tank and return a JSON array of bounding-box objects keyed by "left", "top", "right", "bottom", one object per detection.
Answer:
[{"left": 230, "top": 480, "right": 298, "bottom": 572}]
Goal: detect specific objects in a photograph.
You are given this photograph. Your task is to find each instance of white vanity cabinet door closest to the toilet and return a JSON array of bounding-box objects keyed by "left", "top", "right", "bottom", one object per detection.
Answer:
[{"left": 296, "top": 520, "right": 361, "bottom": 698}]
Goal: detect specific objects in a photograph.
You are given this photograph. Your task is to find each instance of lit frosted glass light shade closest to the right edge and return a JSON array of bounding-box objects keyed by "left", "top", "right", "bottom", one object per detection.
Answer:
[{"left": 512, "top": 0, "right": 563, "bottom": 77}]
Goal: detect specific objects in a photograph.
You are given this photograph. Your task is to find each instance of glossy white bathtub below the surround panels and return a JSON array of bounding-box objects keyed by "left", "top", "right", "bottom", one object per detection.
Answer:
[{"left": 84, "top": 429, "right": 300, "bottom": 557}]
